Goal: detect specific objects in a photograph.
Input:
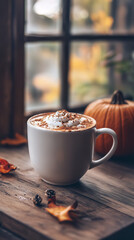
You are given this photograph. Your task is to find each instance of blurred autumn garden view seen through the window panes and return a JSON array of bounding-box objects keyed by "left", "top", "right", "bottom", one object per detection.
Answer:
[{"left": 24, "top": 0, "right": 134, "bottom": 113}]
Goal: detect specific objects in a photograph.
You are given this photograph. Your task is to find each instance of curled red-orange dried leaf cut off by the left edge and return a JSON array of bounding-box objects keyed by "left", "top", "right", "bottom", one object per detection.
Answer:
[{"left": 0, "top": 158, "right": 16, "bottom": 174}]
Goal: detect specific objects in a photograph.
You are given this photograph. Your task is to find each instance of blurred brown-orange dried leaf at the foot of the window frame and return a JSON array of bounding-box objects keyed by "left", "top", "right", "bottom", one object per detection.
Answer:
[{"left": 0, "top": 133, "right": 27, "bottom": 146}]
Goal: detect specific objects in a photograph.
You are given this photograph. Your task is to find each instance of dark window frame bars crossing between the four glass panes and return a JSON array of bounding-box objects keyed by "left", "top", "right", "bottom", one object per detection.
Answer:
[{"left": 15, "top": 0, "right": 134, "bottom": 120}]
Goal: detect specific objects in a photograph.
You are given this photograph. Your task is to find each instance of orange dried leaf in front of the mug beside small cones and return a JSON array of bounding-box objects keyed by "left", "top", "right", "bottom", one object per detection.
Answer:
[{"left": 46, "top": 190, "right": 78, "bottom": 222}]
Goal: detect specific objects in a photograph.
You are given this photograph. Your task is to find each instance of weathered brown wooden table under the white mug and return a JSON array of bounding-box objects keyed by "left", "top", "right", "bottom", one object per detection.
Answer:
[{"left": 0, "top": 146, "right": 134, "bottom": 240}]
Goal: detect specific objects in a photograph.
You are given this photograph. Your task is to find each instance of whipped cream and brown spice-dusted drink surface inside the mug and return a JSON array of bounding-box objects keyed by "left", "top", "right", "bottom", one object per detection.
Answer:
[{"left": 30, "top": 110, "right": 96, "bottom": 131}]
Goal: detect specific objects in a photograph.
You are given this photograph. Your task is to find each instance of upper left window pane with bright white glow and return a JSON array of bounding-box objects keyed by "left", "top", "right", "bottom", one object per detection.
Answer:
[{"left": 25, "top": 0, "right": 61, "bottom": 34}]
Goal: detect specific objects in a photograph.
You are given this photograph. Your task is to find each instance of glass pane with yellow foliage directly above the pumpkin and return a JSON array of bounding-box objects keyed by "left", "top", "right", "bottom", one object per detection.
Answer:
[{"left": 69, "top": 42, "right": 134, "bottom": 107}]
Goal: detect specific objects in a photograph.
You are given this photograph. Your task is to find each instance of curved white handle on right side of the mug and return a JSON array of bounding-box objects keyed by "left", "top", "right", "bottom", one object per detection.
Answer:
[{"left": 90, "top": 128, "right": 118, "bottom": 168}]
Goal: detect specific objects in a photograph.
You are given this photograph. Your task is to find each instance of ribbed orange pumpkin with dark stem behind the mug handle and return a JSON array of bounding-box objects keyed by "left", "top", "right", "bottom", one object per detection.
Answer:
[{"left": 84, "top": 91, "right": 134, "bottom": 156}]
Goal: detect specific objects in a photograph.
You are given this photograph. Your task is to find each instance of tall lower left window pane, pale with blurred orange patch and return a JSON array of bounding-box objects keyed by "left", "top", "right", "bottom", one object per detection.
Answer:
[{"left": 25, "top": 43, "right": 60, "bottom": 112}]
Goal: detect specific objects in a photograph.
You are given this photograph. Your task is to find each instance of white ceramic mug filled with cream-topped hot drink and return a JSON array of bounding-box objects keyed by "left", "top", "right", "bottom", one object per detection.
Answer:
[{"left": 27, "top": 110, "right": 117, "bottom": 186}]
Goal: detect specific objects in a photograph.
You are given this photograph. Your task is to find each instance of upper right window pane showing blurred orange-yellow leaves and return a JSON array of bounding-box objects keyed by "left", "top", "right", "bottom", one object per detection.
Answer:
[{"left": 71, "top": 0, "right": 134, "bottom": 33}]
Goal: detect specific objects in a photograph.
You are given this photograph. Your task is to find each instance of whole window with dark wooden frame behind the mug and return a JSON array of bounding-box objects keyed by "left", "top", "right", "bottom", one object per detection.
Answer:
[{"left": 0, "top": 0, "right": 134, "bottom": 138}]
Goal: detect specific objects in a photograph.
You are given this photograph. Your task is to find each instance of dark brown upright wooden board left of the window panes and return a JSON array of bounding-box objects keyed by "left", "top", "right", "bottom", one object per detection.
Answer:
[{"left": 0, "top": 0, "right": 24, "bottom": 139}]
